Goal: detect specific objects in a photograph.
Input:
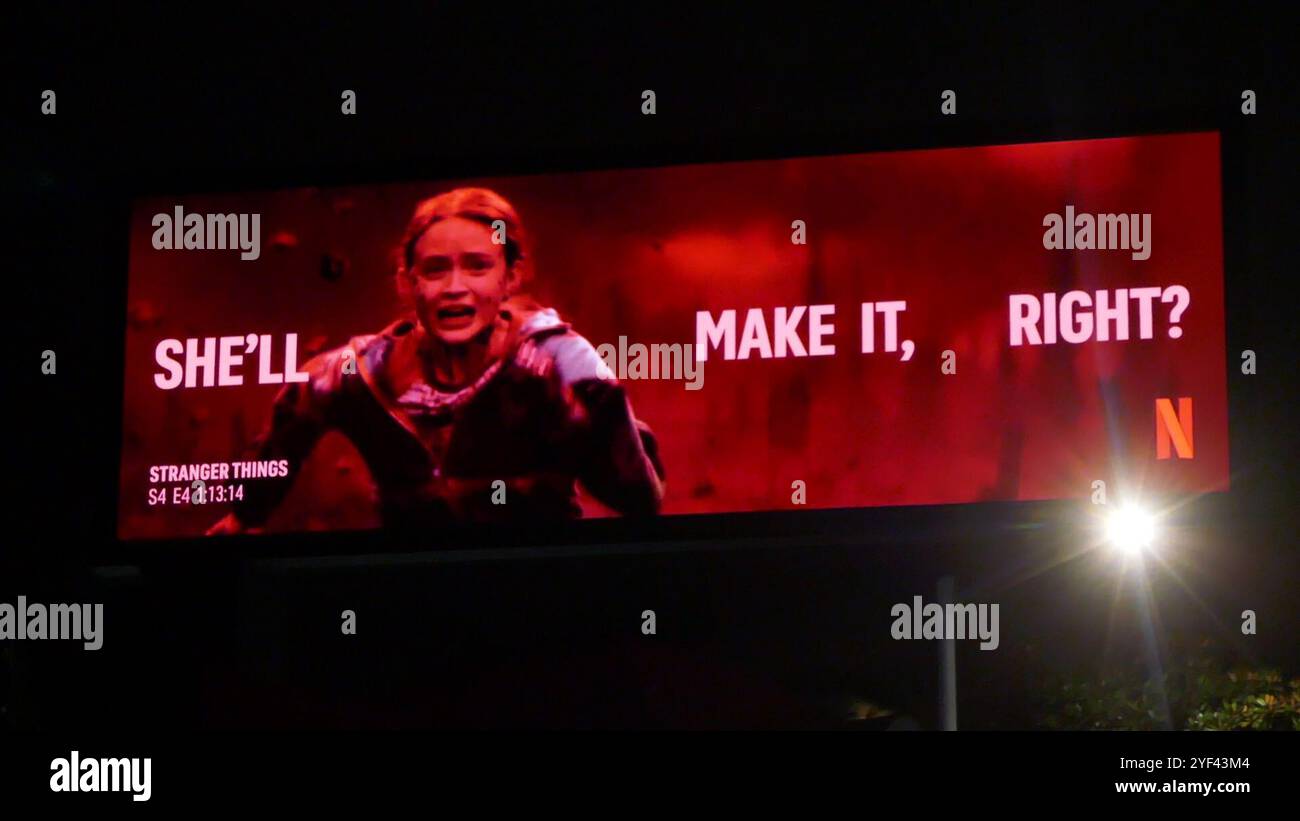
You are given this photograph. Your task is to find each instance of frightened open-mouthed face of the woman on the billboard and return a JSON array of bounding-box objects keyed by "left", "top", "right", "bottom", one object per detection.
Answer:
[{"left": 410, "top": 217, "right": 515, "bottom": 344}]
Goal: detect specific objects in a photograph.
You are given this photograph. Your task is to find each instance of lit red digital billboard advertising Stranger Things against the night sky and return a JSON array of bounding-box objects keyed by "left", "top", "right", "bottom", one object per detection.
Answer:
[{"left": 118, "top": 133, "right": 1229, "bottom": 539}]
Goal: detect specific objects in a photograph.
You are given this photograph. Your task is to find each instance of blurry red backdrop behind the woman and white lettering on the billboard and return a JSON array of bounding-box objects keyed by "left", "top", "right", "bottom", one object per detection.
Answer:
[{"left": 120, "top": 134, "right": 1229, "bottom": 538}]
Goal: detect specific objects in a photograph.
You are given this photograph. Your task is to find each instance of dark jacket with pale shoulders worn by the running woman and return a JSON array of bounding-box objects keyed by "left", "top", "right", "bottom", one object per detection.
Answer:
[{"left": 234, "top": 303, "right": 664, "bottom": 527}]
